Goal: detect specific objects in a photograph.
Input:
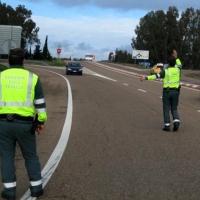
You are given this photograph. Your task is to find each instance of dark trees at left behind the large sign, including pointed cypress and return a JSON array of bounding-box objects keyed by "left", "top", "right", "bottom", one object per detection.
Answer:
[{"left": 0, "top": 1, "right": 52, "bottom": 60}]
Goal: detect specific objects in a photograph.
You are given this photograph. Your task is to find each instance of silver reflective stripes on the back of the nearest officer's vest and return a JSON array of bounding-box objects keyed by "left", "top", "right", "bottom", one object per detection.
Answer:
[{"left": 0, "top": 72, "right": 34, "bottom": 107}]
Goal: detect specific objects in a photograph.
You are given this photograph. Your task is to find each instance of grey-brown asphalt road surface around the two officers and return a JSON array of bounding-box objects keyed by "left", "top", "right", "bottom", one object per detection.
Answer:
[{"left": 1, "top": 62, "right": 200, "bottom": 200}]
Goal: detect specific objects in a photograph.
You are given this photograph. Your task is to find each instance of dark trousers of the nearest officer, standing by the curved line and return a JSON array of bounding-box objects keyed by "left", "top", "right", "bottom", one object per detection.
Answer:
[{"left": 0, "top": 119, "right": 42, "bottom": 195}]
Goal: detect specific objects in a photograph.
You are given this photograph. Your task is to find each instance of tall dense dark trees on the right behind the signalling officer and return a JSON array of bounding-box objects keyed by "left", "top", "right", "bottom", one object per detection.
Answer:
[{"left": 115, "top": 6, "right": 200, "bottom": 69}]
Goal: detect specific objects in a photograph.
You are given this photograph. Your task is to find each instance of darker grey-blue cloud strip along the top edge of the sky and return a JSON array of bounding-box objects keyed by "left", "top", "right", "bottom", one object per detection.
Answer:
[{"left": 28, "top": 0, "right": 199, "bottom": 11}]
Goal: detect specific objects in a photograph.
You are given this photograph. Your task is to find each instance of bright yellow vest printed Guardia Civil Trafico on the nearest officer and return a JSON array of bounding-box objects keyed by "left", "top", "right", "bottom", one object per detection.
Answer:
[{"left": 0, "top": 68, "right": 47, "bottom": 121}]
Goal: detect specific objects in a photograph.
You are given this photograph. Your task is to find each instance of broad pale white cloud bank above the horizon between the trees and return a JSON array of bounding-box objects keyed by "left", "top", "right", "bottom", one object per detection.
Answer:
[{"left": 32, "top": 16, "right": 139, "bottom": 60}]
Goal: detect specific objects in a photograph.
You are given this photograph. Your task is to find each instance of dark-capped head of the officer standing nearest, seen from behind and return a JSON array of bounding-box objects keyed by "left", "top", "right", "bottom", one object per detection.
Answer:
[{"left": 8, "top": 48, "right": 25, "bottom": 65}]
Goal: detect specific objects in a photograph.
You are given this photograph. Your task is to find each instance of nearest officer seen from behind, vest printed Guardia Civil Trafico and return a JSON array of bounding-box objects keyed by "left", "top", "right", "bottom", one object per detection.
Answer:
[{"left": 0, "top": 48, "right": 47, "bottom": 200}]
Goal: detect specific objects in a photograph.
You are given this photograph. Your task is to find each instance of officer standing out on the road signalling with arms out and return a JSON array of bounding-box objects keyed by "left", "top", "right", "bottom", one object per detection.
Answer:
[{"left": 140, "top": 56, "right": 181, "bottom": 131}]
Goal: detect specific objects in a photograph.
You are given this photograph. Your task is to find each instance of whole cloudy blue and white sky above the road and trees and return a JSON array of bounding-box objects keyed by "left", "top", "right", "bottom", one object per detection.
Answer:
[{"left": 1, "top": 0, "right": 200, "bottom": 61}]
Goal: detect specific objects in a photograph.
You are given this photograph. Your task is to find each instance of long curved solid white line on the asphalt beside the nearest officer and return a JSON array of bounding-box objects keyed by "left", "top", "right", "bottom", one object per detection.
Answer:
[{"left": 21, "top": 69, "right": 73, "bottom": 200}]
